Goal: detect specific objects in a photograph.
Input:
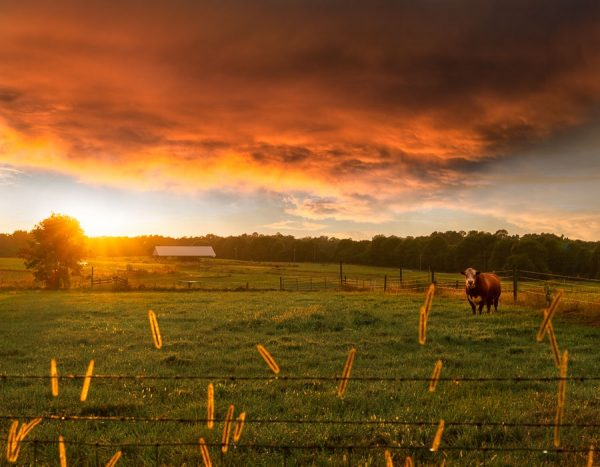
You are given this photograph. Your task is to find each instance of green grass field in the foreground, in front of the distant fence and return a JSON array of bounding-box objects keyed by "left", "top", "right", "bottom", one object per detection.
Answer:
[{"left": 0, "top": 291, "right": 600, "bottom": 466}]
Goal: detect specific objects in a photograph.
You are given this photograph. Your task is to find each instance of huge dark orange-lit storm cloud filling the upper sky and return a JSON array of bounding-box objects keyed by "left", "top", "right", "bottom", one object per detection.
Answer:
[{"left": 0, "top": 0, "right": 600, "bottom": 238}]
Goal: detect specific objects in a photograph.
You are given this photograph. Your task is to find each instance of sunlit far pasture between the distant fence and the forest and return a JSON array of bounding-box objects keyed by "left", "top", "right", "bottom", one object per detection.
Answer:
[{"left": 0, "top": 257, "right": 450, "bottom": 290}]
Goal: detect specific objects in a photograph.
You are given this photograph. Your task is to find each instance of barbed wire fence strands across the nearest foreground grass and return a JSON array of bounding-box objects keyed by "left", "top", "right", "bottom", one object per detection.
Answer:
[{"left": 0, "top": 374, "right": 600, "bottom": 466}]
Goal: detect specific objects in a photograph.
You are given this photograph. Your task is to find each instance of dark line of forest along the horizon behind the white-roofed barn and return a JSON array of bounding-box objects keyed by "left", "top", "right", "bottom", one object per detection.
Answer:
[{"left": 0, "top": 230, "right": 600, "bottom": 278}]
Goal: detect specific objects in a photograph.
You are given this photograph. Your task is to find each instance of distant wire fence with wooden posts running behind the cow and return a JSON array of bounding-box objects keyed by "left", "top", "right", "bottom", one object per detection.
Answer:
[{"left": 0, "top": 264, "right": 600, "bottom": 307}]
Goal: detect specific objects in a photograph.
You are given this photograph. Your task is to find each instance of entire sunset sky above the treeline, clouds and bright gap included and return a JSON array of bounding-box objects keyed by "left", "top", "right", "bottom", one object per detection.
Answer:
[{"left": 0, "top": 0, "right": 600, "bottom": 240}]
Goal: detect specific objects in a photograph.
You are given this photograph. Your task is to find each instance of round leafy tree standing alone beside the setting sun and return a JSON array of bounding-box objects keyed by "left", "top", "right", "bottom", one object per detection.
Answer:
[{"left": 20, "top": 214, "right": 86, "bottom": 289}]
